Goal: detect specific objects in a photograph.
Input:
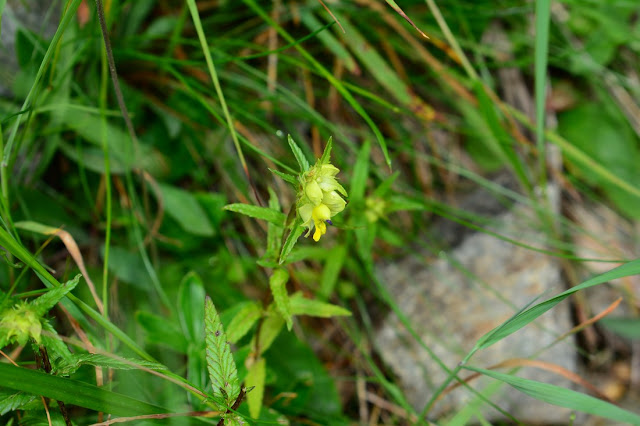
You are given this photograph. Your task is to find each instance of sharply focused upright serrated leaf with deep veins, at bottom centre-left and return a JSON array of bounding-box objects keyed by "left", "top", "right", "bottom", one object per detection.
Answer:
[{"left": 204, "top": 296, "right": 240, "bottom": 411}]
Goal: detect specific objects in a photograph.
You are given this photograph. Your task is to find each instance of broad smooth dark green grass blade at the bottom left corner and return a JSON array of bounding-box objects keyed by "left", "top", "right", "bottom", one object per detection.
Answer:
[{"left": 0, "top": 363, "right": 168, "bottom": 416}]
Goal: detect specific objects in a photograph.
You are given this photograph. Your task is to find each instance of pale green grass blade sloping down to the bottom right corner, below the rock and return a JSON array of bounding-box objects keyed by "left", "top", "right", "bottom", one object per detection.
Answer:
[{"left": 464, "top": 366, "right": 640, "bottom": 425}]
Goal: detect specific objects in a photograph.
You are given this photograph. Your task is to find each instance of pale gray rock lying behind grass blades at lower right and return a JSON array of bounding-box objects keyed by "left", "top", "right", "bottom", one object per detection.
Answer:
[{"left": 375, "top": 186, "right": 576, "bottom": 423}]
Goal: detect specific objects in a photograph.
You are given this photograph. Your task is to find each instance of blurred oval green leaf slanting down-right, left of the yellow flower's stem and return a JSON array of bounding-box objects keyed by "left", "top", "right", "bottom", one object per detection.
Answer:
[{"left": 158, "top": 184, "right": 214, "bottom": 237}]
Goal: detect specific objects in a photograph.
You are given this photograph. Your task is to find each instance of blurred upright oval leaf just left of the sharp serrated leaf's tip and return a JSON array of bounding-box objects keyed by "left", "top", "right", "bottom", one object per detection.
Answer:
[{"left": 178, "top": 271, "right": 206, "bottom": 343}]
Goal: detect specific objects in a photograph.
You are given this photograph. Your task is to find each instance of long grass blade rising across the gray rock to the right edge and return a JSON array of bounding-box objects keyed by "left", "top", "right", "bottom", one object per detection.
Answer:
[{"left": 472, "top": 259, "right": 640, "bottom": 352}]
